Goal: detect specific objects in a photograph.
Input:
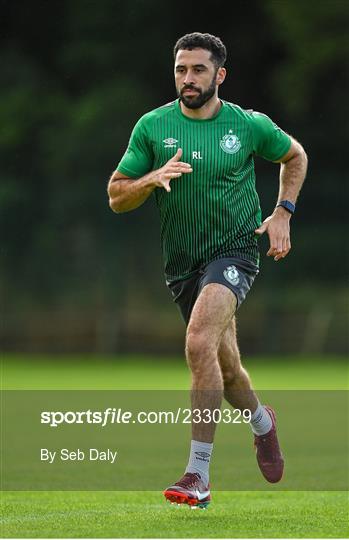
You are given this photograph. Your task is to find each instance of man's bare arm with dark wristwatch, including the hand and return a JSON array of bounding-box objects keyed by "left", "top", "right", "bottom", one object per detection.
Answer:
[{"left": 255, "top": 137, "right": 308, "bottom": 261}]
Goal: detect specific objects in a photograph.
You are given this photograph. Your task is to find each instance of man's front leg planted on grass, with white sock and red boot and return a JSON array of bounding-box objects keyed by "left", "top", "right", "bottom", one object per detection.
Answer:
[{"left": 164, "top": 283, "right": 236, "bottom": 506}]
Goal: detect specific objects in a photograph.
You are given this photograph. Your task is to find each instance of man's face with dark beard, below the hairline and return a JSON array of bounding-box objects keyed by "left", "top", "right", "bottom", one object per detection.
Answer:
[{"left": 175, "top": 49, "right": 225, "bottom": 109}]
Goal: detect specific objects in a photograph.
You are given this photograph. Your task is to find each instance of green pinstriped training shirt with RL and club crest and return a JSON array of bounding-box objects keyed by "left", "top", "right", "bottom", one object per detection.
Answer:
[{"left": 117, "top": 99, "right": 291, "bottom": 281}]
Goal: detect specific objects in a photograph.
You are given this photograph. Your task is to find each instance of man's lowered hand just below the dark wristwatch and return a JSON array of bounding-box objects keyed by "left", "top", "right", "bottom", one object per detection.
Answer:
[{"left": 255, "top": 206, "right": 291, "bottom": 261}]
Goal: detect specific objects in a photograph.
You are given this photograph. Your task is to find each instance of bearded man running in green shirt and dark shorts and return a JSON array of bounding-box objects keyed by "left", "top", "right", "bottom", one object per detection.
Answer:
[{"left": 108, "top": 32, "right": 307, "bottom": 507}]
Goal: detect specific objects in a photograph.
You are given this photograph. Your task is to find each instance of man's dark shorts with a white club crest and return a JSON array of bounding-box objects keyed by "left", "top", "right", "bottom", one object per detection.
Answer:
[{"left": 167, "top": 257, "right": 259, "bottom": 325}]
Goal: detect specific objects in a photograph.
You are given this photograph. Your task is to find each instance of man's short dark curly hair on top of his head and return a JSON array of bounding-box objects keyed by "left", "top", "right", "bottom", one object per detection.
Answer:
[{"left": 173, "top": 32, "right": 227, "bottom": 68}]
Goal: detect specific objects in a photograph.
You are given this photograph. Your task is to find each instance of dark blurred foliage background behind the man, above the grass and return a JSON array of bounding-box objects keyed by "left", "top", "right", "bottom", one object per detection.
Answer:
[{"left": 0, "top": 0, "right": 349, "bottom": 353}]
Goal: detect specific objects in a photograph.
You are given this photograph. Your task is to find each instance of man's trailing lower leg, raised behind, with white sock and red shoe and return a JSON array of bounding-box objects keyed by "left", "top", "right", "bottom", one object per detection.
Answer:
[{"left": 218, "top": 319, "right": 284, "bottom": 483}]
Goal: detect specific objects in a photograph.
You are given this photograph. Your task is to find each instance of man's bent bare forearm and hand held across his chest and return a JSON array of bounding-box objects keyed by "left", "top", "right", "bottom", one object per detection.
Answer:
[{"left": 108, "top": 148, "right": 192, "bottom": 213}]
